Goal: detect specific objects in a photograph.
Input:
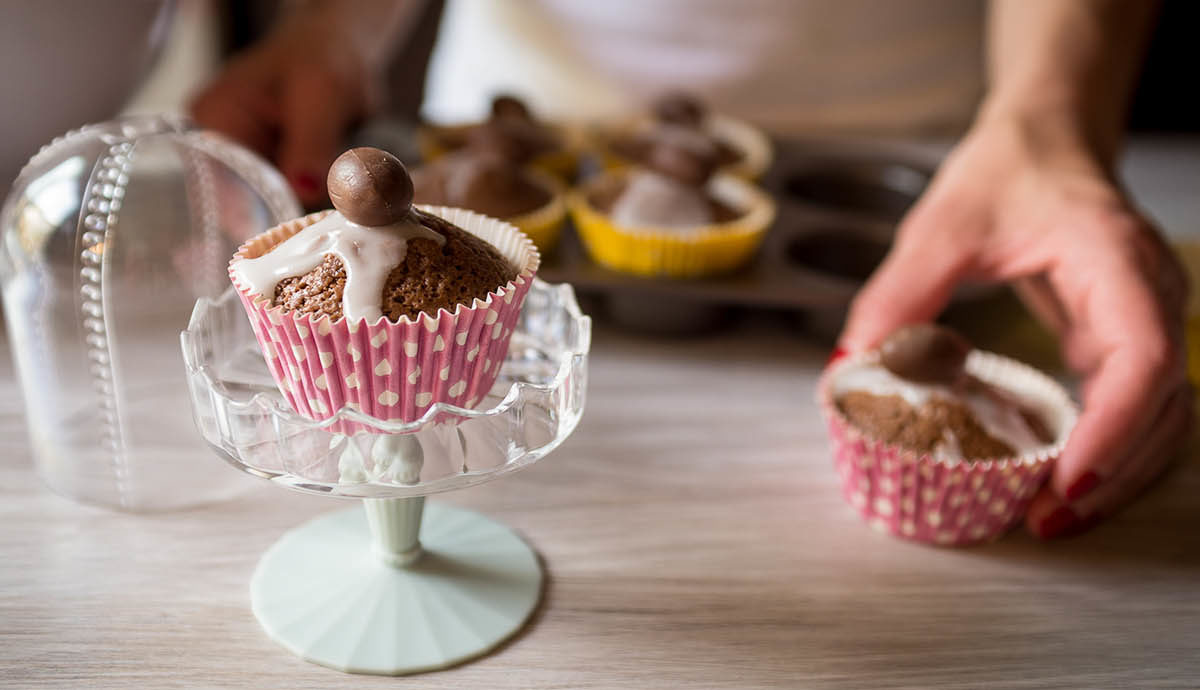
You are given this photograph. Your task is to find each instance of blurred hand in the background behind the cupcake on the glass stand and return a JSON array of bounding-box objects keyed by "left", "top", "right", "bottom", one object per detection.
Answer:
[{"left": 191, "top": 5, "right": 380, "bottom": 208}]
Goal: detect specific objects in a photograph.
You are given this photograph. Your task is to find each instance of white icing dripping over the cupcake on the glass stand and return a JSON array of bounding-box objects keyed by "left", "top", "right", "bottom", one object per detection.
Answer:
[{"left": 233, "top": 211, "right": 446, "bottom": 322}]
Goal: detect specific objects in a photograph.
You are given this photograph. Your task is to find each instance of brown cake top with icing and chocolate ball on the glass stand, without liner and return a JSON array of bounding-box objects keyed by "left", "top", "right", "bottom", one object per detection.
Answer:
[{"left": 230, "top": 148, "right": 517, "bottom": 322}]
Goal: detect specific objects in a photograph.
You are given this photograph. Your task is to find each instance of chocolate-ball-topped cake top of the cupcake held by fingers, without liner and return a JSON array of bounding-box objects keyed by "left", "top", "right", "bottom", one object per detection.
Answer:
[{"left": 832, "top": 324, "right": 1052, "bottom": 461}]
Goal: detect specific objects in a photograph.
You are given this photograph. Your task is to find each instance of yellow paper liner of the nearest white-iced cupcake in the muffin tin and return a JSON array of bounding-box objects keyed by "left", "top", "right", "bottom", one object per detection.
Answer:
[{"left": 566, "top": 172, "right": 775, "bottom": 278}]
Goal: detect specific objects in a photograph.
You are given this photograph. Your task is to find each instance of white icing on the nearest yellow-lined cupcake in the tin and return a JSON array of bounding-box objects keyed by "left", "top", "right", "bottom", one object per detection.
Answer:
[{"left": 610, "top": 170, "right": 714, "bottom": 228}]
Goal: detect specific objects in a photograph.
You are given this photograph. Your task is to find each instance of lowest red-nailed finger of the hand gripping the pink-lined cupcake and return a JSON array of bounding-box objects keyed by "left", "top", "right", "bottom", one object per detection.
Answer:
[{"left": 1025, "top": 386, "right": 1194, "bottom": 539}]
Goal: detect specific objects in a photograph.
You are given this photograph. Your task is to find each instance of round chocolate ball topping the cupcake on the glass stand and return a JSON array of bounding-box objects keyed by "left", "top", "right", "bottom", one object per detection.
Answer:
[{"left": 326, "top": 146, "right": 413, "bottom": 226}]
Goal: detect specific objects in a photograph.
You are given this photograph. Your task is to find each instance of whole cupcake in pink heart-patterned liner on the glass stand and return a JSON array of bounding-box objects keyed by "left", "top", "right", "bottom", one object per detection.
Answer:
[{"left": 229, "top": 148, "right": 539, "bottom": 422}]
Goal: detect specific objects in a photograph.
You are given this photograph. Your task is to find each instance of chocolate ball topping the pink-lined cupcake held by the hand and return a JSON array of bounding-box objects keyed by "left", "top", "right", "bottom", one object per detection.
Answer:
[{"left": 880, "top": 324, "right": 971, "bottom": 384}]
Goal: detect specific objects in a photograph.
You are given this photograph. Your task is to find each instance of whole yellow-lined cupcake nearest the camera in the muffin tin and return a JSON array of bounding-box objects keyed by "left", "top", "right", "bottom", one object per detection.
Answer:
[{"left": 568, "top": 139, "right": 775, "bottom": 278}]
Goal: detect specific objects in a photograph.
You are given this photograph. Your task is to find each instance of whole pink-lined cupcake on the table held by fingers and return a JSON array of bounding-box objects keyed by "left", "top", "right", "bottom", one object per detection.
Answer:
[{"left": 818, "top": 324, "right": 1076, "bottom": 545}]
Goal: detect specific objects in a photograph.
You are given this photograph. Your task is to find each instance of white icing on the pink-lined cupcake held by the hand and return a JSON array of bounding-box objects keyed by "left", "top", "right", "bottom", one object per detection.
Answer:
[{"left": 832, "top": 362, "right": 1046, "bottom": 460}]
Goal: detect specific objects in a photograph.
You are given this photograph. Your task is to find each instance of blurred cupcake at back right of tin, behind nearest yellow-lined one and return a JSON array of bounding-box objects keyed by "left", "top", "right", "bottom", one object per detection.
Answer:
[{"left": 599, "top": 92, "right": 772, "bottom": 180}]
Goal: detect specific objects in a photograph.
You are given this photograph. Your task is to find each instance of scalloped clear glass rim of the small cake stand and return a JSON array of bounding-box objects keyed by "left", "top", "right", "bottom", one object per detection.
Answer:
[{"left": 180, "top": 278, "right": 592, "bottom": 433}]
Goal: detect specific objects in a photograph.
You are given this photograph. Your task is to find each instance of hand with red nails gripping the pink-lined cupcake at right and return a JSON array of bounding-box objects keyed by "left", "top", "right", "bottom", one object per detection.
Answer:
[{"left": 840, "top": 112, "right": 1193, "bottom": 538}]
